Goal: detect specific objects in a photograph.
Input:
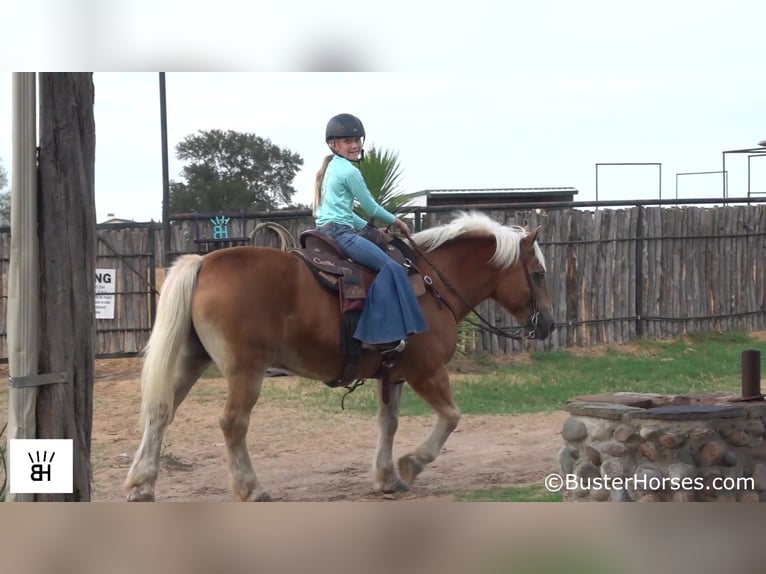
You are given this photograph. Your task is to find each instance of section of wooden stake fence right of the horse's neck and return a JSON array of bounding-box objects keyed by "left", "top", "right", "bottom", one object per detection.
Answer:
[{"left": 456, "top": 204, "right": 766, "bottom": 353}]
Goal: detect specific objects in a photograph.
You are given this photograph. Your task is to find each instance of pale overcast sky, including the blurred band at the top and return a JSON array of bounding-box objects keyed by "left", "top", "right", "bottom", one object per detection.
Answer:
[{"left": 0, "top": 0, "right": 766, "bottom": 221}]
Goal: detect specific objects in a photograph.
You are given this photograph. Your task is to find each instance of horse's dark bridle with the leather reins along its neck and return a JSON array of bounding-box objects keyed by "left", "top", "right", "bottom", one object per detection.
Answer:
[{"left": 404, "top": 233, "right": 540, "bottom": 340}]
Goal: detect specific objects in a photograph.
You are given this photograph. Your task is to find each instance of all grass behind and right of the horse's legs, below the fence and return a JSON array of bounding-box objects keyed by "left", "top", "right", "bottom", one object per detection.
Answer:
[{"left": 263, "top": 333, "right": 766, "bottom": 416}]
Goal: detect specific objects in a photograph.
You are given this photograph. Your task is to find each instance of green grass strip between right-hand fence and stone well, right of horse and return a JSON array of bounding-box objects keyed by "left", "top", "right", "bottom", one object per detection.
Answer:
[{"left": 453, "top": 333, "right": 766, "bottom": 414}]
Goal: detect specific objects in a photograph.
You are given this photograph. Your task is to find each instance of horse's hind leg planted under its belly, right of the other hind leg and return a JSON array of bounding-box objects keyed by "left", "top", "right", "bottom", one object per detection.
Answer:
[{"left": 220, "top": 368, "right": 271, "bottom": 502}]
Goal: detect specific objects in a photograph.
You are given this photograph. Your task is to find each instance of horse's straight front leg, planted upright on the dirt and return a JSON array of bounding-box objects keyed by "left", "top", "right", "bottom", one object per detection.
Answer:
[{"left": 373, "top": 381, "right": 409, "bottom": 493}]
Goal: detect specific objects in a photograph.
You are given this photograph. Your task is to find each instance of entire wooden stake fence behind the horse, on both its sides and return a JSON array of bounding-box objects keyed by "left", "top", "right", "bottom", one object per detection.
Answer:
[{"left": 0, "top": 203, "right": 766, "bottom": 358}]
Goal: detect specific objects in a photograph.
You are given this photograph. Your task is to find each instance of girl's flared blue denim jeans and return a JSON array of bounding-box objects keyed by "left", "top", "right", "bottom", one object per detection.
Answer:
[{"left": 318, "top": 223, "right": 428, "bottom": 344}]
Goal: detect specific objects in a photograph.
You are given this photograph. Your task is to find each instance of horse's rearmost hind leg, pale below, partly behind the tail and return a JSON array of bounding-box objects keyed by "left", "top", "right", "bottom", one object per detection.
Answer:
[{"left": 124, "top": 350, "right": 210, "bottom": 502}]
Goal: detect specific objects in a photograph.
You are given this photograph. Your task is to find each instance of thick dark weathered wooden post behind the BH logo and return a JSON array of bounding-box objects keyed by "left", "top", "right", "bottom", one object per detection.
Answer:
[{"left": 35, "top": 73, "right": 96, "bottom": 501}]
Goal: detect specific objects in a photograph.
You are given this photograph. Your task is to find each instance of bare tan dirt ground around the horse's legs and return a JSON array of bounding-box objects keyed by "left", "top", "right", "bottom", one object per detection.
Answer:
[{"left": 91, "top": 359, "right": 567, "bottom": 501}]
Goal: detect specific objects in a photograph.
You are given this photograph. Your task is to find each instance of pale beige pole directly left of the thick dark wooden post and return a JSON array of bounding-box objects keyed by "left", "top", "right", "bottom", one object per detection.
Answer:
[{"left": 7, "top": 72, "right": 40, "bottom": 502}]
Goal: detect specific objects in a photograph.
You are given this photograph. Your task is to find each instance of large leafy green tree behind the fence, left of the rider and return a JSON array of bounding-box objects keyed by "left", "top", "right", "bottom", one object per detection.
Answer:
[{"left": 170, "top": 130, "right": 303, "bottom": 213}]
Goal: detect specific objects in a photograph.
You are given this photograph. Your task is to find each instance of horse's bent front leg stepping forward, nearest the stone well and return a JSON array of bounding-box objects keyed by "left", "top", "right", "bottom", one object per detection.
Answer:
[{"left": 397, "top": 367, "right": 460, "bottom": 484}]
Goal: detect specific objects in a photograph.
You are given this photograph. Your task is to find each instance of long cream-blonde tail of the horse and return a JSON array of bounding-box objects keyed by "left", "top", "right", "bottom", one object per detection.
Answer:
[{"left": 140, "top": 255, "right": 202, "bottom": 424}]
